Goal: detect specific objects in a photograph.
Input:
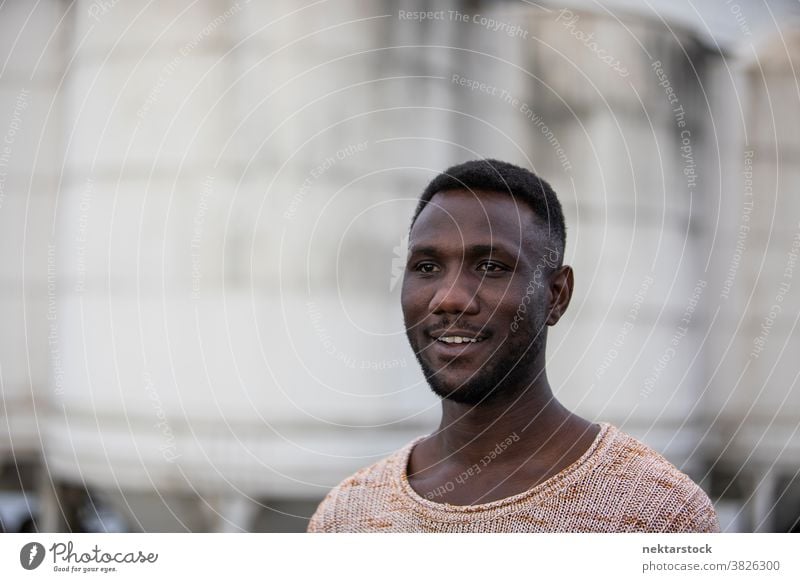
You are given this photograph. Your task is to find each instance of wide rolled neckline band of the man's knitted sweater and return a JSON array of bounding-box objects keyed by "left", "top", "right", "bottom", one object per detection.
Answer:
[{"left": 391, "top": 422, "right": 616, "bottom": 520}]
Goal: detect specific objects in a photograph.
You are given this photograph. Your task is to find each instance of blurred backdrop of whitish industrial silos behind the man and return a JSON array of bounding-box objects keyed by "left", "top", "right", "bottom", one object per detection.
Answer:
[{"left": 0, "top": 0, "right": 800, "bottom": 531}]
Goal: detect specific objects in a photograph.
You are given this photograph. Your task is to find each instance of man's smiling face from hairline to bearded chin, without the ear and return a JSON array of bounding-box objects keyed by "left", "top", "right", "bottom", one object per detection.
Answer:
[{"left": 401, "top": 190, "right": 560, "bottom": 404}]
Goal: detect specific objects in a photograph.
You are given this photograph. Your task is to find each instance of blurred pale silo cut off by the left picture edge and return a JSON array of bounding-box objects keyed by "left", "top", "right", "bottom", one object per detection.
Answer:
[{"left": 0, "top": 0, "right": 69, "bottom": 531}]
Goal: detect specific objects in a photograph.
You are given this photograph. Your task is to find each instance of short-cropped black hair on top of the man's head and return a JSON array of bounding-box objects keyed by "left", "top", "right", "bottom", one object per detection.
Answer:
[{"left": 411, "top": 159, "right": 567, "bottom": 257}]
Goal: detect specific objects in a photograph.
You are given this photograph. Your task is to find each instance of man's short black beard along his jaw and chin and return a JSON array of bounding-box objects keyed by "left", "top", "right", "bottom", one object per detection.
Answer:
[{"left": 409, "top": 309, "right": 547, "bottom": 406}]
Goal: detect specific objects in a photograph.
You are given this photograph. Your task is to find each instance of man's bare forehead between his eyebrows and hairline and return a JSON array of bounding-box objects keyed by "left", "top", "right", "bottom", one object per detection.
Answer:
[{"left": 410, "top": 190, "right": 541, "bottom": 249}]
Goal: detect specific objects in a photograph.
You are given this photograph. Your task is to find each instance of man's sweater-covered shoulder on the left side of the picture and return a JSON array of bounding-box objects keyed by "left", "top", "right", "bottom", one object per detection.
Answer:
[{"left": 307, "top": 439, "right": 419, "bottom": 533}]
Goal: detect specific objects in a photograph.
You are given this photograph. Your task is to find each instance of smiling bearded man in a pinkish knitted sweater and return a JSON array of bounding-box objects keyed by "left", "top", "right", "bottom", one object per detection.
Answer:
[{"left": 308, "top": 160, "right": 719, "bottom": 532}]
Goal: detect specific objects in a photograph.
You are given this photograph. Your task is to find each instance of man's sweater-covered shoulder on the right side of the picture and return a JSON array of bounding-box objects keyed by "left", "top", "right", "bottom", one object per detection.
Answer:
[{"left": 593, "top": 427, "right": 719, "bottom": 532}]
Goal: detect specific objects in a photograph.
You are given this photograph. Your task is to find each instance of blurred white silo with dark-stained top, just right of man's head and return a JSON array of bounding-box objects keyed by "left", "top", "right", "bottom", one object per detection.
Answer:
[{"left": 521, "top": 9, "right": 715, "bottom": 460}]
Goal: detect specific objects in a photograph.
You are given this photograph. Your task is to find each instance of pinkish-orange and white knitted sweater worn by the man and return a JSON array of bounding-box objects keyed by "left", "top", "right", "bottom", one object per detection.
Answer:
[{"left": 308, "top": 423, "right": 719, "bottom": 533}]
